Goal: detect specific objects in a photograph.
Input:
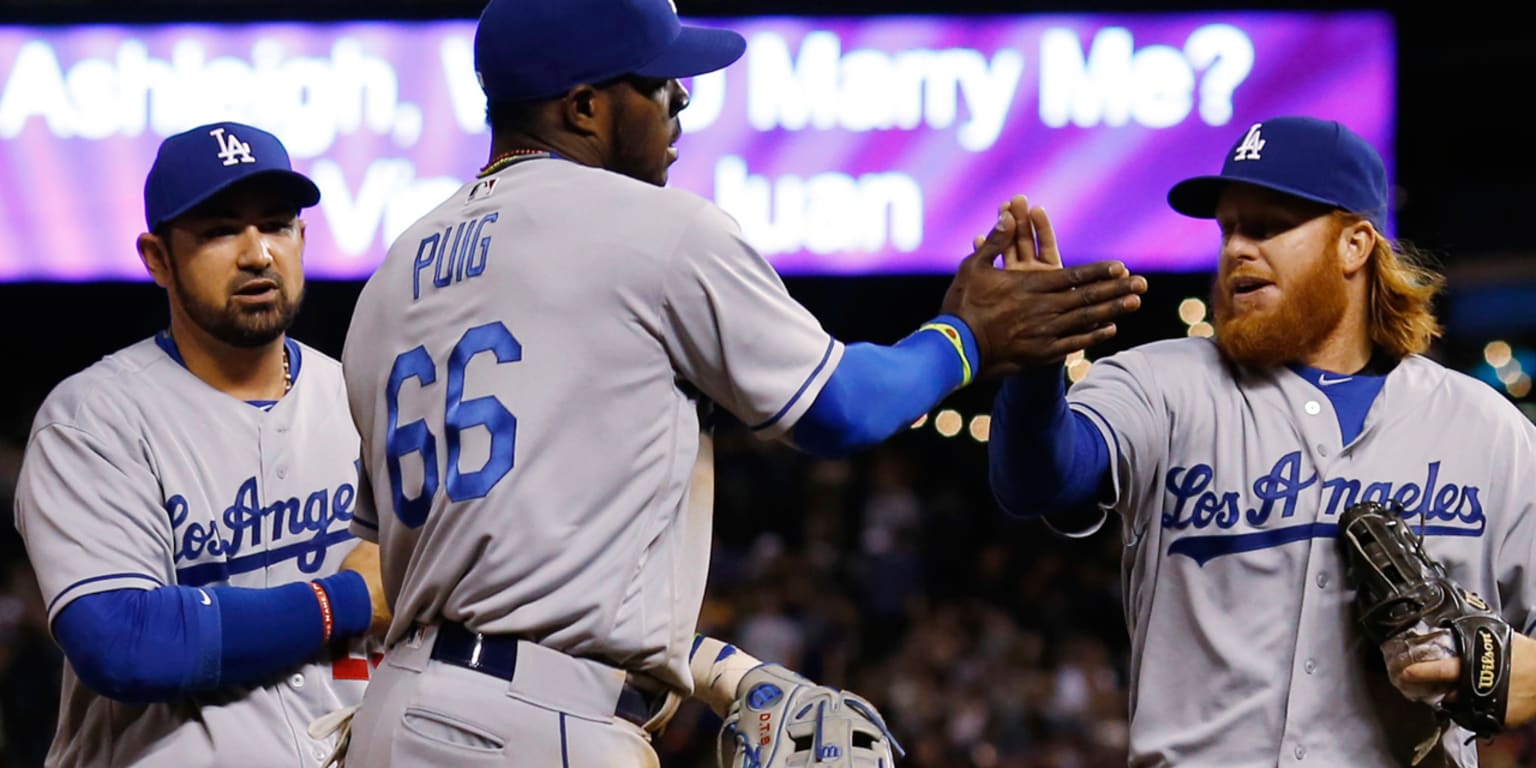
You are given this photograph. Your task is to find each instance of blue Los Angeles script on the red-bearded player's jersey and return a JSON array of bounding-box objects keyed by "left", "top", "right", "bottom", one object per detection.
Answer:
[{"left": 1163, "top": 452, "right": 1487, "bottom": 536}]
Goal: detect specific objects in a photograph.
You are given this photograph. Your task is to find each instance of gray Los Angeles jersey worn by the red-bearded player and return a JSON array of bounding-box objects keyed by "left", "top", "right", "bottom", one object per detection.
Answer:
[{"left": 1068, "top": 339, "right": 1536, "bottom": 768}]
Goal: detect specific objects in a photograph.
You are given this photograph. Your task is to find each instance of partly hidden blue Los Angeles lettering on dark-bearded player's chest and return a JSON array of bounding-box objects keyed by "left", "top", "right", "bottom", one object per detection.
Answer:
[{"left": 166, "top": 476, "right": 356, "bottom": 585}]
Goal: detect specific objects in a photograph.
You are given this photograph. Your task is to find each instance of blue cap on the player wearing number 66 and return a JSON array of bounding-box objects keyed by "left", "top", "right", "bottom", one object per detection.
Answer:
[{"left": 475, "top": 0, "right": 746, "bottom": 103}]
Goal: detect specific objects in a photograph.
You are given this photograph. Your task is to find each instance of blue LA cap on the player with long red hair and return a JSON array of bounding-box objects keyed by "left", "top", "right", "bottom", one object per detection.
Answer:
[{"left": 1167, "top": 117, "right": 1387, "bottom": 232}]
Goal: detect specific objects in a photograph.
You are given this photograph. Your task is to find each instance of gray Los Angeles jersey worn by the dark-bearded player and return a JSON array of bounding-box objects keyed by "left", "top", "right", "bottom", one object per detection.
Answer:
[{"left": 15, "top": 338, "right": 369, "bottom": 768}]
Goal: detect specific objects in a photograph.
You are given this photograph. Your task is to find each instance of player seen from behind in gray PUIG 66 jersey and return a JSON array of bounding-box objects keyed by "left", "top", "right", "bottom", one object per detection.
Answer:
[{"left": 343, "top": 0, "right": 1144, "bottom": 768}]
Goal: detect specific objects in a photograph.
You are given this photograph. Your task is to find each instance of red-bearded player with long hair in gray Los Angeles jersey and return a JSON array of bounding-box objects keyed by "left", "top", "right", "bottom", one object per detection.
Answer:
[{"left": 989, "top": 117, "right": 1536, "bottom": 768}]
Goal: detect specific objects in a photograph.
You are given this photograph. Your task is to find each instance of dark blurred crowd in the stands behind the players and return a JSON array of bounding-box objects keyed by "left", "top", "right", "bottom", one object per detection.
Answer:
[{"left": 0, "top": 405, "right": 1536, "bottom": 768}]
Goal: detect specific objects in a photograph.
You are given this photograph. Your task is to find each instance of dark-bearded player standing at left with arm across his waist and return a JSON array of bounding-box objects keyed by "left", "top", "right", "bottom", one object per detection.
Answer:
[{"left": 15, "top": 123, "right": 387, "bottom": 768}]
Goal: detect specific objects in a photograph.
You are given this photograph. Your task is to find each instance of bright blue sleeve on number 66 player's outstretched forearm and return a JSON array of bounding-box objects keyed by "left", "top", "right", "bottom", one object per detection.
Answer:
[{"left": 794, "top": 315, "right": 980, "bottom": 456}]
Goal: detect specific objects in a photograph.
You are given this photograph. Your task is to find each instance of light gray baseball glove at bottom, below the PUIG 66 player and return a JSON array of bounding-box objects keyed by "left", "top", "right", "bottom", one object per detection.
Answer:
[{"left": 716, "top": 664, "right": 906, "bottom": 768}]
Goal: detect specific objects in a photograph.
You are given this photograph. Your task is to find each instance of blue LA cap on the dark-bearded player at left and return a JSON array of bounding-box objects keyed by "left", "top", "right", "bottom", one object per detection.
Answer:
[{"left": 144, "top": 123, "right": 319, "bottom": 232}]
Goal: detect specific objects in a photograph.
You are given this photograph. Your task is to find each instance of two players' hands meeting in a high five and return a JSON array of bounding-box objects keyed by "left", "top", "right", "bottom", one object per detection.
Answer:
[{"left": 943, "top": 195, "right": 1147, "bottom": 378}]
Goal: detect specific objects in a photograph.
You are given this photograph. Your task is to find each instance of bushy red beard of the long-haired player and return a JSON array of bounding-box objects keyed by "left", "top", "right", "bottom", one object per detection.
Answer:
[{"left": 1210, "top": 260, "right": 1349, "bottom": 367}]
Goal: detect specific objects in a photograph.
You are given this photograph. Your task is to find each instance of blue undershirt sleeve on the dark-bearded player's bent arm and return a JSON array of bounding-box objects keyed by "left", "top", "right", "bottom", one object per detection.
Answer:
[{"left": 54, "top": 570, "right": 372, "bottom": 703}]
